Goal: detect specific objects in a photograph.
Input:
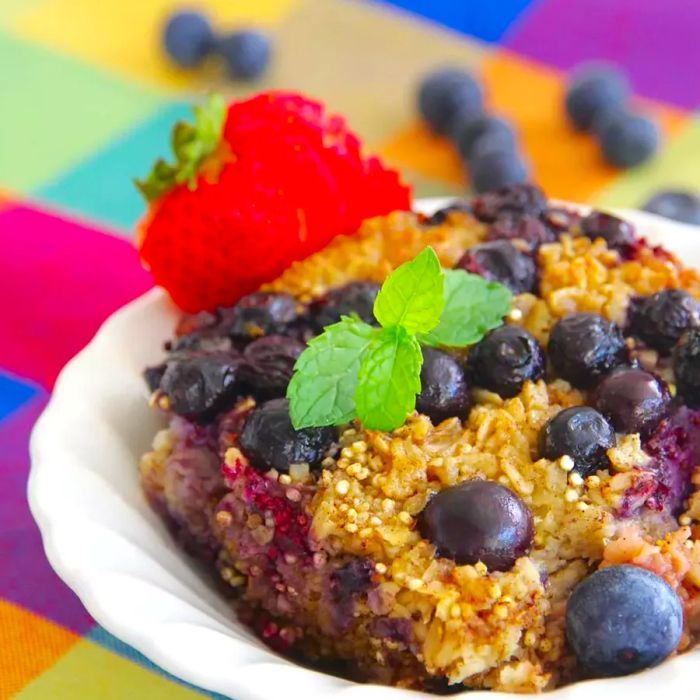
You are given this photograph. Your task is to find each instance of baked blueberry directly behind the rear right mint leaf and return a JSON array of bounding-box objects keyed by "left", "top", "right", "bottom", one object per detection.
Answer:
[{"left": 456, "top": 241, "right": 537, "bottom": 294}]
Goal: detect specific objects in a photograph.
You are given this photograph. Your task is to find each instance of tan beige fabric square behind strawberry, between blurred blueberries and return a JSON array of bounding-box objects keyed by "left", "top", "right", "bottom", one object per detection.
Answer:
[{"left": 250, "top": 0, "right": 487, "bottom": 150}]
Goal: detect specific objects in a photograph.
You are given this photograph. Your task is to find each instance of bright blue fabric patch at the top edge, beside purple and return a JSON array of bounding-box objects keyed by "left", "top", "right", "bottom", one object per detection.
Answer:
[{"left": 372, "top": 0, "right": 537, "bottom": 42}]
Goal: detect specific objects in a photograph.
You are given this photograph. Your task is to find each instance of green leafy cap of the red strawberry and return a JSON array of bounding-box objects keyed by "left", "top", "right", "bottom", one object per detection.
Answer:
[{"left": 134, "top": 95, "right": 226, "bottom": 202}]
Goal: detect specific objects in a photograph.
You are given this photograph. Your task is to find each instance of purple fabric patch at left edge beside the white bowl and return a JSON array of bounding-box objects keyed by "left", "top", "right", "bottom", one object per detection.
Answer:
[{"left": 0, "top": 393, "right": 95, "bottom": 634}]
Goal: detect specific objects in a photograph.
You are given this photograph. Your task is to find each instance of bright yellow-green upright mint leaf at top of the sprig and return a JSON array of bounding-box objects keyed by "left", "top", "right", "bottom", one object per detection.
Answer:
[{"left": 374, "top": 248, "right": 445, "bottom": 333}]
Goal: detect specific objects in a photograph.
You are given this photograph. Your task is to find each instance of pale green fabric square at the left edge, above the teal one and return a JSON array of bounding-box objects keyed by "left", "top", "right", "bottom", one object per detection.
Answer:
[{"left": 0, "top": 32, "right": 165, "bottom": 192}]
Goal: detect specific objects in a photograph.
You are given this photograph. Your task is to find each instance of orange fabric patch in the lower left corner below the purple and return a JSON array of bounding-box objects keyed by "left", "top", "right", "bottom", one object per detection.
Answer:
[{"left": 0, "top": 600, "right": 80, "bottom": 698}]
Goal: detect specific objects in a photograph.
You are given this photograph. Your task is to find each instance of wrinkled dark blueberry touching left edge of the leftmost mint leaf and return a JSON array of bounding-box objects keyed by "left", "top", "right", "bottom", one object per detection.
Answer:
[{"left": 241, "top": 335, "right": 305, "bottom": 398}]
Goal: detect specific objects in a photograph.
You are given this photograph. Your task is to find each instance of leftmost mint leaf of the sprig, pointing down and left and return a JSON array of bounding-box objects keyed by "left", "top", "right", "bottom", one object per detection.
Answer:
[{"left": 287, "top": 316, "right": 380, "bottom": 430}]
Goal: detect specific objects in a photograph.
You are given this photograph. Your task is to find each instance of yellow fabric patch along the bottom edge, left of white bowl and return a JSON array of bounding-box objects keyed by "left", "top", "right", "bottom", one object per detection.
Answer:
[{"left": 16, "top": 640, "right": 208, "bottom": 700}]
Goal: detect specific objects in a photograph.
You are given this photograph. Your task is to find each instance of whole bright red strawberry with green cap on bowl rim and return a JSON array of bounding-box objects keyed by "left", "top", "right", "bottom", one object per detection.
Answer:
[{"left": 137, "top": 92, "right": 410, "bottom": 312}]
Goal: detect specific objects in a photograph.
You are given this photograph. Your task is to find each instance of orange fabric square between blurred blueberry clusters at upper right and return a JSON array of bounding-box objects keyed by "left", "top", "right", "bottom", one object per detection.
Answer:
[{"left": 482, "top": 50, "right": 688, "bottom": 202}]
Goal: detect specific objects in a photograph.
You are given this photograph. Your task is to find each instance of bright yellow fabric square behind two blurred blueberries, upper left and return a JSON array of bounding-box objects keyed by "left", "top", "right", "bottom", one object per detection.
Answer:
[{"left": 11, "top": 0, "right": 296, "bottom": 91}]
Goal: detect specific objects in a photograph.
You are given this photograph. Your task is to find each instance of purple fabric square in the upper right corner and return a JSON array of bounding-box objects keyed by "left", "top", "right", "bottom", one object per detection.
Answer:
[{"left": 503, "top": 0, "right": 700, "bottom": 109}]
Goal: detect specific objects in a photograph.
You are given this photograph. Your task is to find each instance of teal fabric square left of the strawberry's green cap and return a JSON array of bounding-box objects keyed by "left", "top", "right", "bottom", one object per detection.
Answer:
[{"left": 34, "top": 103, "right": 191, "bottom": 233}]
